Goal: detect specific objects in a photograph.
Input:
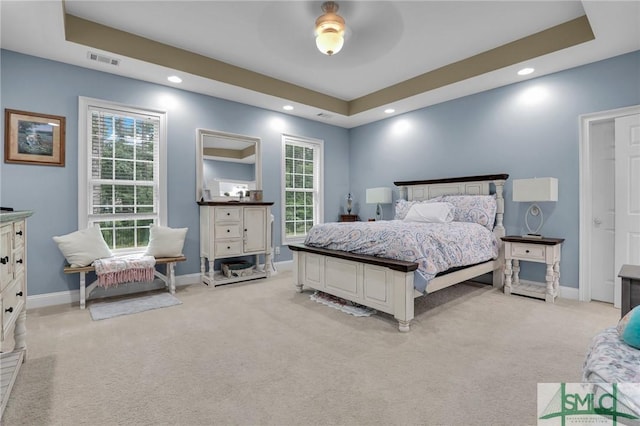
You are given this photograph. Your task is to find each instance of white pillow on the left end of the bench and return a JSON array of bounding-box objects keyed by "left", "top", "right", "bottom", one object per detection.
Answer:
[{"left": 53, "top": 226, "right": 112, "bottom": 268}]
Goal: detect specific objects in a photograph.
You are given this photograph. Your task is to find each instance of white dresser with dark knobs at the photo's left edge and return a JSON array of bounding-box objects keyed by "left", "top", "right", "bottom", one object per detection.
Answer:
[{"left": 0, "top": 211, "right": 33, "bottom": 417}]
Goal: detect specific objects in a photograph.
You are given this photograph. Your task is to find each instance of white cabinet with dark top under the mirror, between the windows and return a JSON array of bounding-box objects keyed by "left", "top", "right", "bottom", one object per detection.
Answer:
[{"left": 198, "top": 202, "right": 273, "bottom": 286}]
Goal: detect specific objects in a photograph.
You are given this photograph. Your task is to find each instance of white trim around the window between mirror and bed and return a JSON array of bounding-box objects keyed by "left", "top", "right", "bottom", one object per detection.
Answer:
[{"left": 280, "top": 133, "right": 324, "bottom": 245}]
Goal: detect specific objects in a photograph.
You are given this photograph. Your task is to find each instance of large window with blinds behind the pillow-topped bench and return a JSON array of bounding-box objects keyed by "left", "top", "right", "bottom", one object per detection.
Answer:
[{"left": 78, "top": 97, "right": 167, "bottom": 252}]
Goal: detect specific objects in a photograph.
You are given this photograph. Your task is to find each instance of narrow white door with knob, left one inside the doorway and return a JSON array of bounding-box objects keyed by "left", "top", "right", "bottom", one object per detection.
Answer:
[{"left": 589, "top": 120, "right": 617, "bottom": 303}]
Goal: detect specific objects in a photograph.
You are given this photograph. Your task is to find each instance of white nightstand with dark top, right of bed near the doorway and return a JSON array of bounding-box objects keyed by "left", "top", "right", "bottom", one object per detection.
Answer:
[{"left": 502, "top": 236, "right": 564, "bottom": 303}]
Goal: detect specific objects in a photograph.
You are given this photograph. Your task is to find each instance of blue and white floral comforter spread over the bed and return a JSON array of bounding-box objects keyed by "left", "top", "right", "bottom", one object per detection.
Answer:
[{"left": 304, "top": 220, "right": 499, "bottom": 292}]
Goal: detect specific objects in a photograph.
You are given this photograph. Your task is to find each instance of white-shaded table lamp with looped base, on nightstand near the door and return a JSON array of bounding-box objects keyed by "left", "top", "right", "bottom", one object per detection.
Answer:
[{"left": 513, "top": 178, "right": 558, "bottom": 238}]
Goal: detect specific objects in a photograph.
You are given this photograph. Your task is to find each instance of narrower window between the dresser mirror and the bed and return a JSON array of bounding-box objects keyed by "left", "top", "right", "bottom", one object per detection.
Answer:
[{"left": 282, "top": 135, "right": 324, "bottom": 244}]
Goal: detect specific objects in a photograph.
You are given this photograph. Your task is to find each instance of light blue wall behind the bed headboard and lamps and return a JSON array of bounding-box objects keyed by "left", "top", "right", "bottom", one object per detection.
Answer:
[{"left": 349, "top": 52, "right": 640, "bottom": 288}]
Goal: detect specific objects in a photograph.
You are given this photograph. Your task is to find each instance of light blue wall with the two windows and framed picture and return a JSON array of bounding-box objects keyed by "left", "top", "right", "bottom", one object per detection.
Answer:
[{"left": 0, "top": 50, "right": 349, "bottom": 295}]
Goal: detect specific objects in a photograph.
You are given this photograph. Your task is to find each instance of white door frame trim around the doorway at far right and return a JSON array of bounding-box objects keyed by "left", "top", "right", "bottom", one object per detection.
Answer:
[{"left": 578, "top": 105, "right": 640, "bottom": 307}]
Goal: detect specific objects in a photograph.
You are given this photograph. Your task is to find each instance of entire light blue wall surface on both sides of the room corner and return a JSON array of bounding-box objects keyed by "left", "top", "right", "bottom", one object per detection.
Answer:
[{"left": 0, "top": 50, "right": 640, "bottom": 295}]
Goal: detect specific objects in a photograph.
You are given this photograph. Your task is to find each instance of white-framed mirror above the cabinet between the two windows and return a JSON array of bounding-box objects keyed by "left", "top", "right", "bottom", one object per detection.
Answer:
[{"left": 196, "top": 129, "right": 262, "bottom": 201}]
